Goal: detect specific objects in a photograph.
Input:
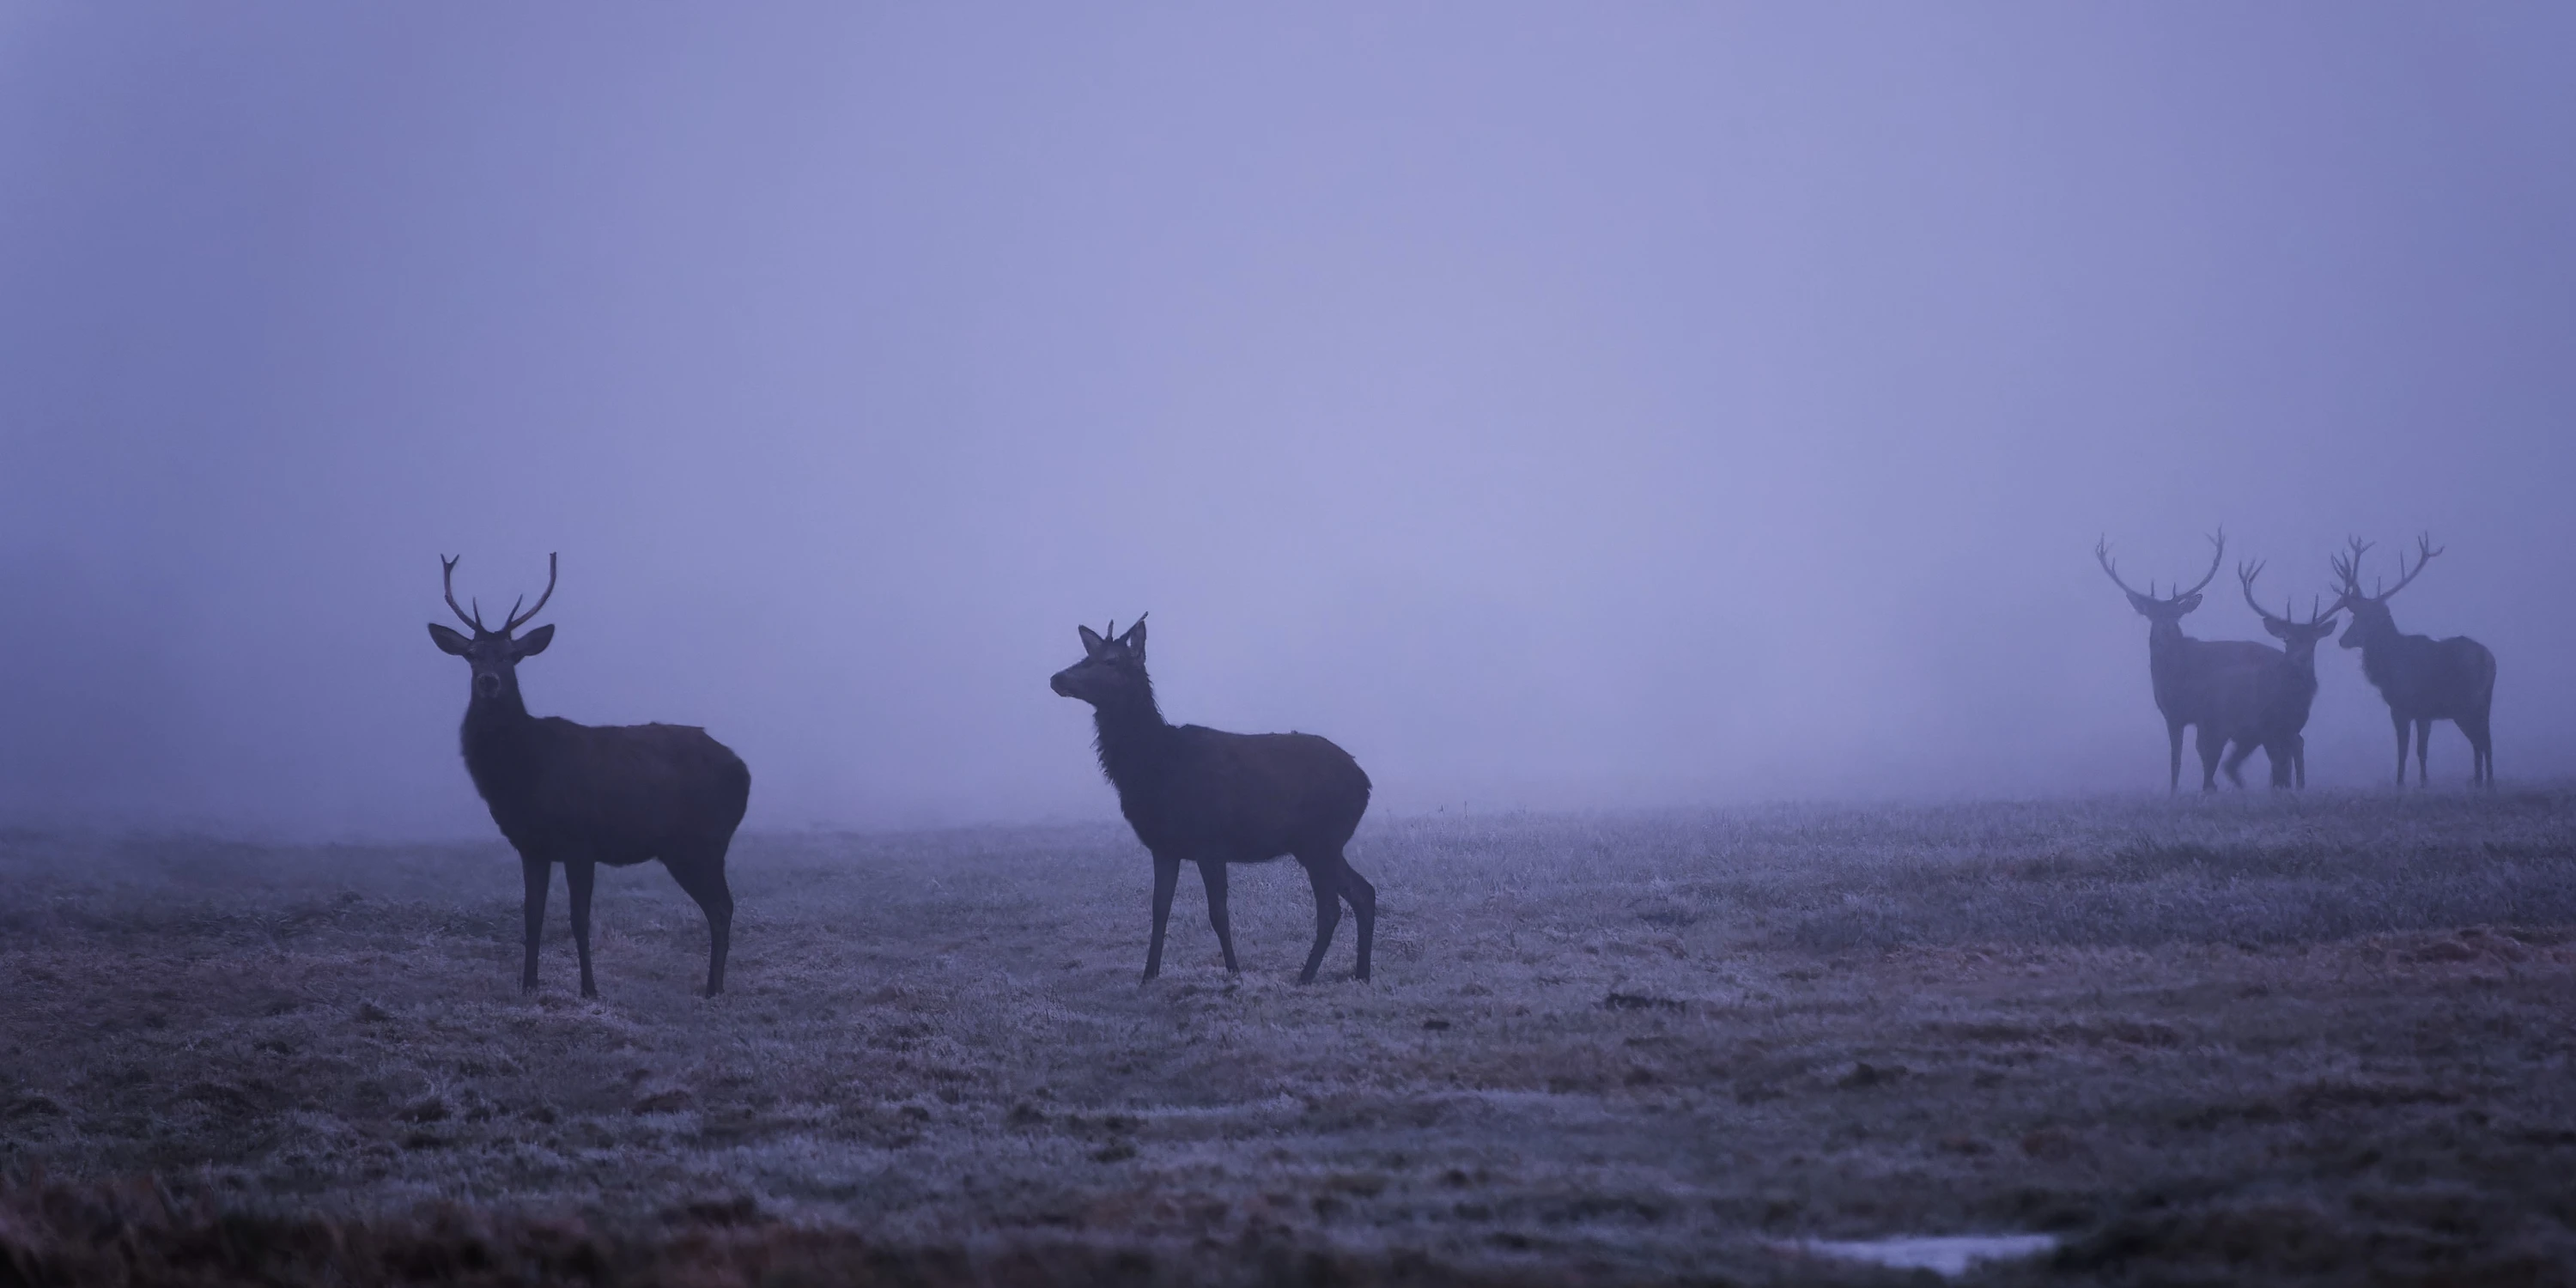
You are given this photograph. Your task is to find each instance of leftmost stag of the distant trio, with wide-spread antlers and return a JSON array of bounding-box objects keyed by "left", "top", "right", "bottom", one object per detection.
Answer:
[{"left": 2094, "top": 531, "right": 2280, "bottom": 791}]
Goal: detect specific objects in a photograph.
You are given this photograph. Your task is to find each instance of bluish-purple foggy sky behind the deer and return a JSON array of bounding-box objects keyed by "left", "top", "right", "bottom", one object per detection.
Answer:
[{"left": 0, "top": 3, "right": 2576, "bottom": 837}]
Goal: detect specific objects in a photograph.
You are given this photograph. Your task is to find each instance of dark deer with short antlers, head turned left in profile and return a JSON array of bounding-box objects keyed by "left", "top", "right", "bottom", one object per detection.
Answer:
[{"left": 1048, "top": 618, "right": 1378, "bottom": 984}]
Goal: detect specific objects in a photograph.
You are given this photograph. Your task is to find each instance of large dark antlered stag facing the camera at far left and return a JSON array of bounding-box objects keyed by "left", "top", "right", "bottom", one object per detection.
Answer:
[{"left": 430, "top": 554, "right": 752, "bottom": 997}]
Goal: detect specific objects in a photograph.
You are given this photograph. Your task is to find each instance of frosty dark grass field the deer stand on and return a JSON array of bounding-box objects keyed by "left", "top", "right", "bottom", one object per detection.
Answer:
[{"left": 0, "top": 791, "right": 2576, "bottom": 1283}]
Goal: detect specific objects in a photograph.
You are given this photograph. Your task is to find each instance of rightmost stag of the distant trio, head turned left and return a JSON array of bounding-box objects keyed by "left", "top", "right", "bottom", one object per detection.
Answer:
[{"left": 2331, "top": 533, "right": 2496, "bottom": 788}]
